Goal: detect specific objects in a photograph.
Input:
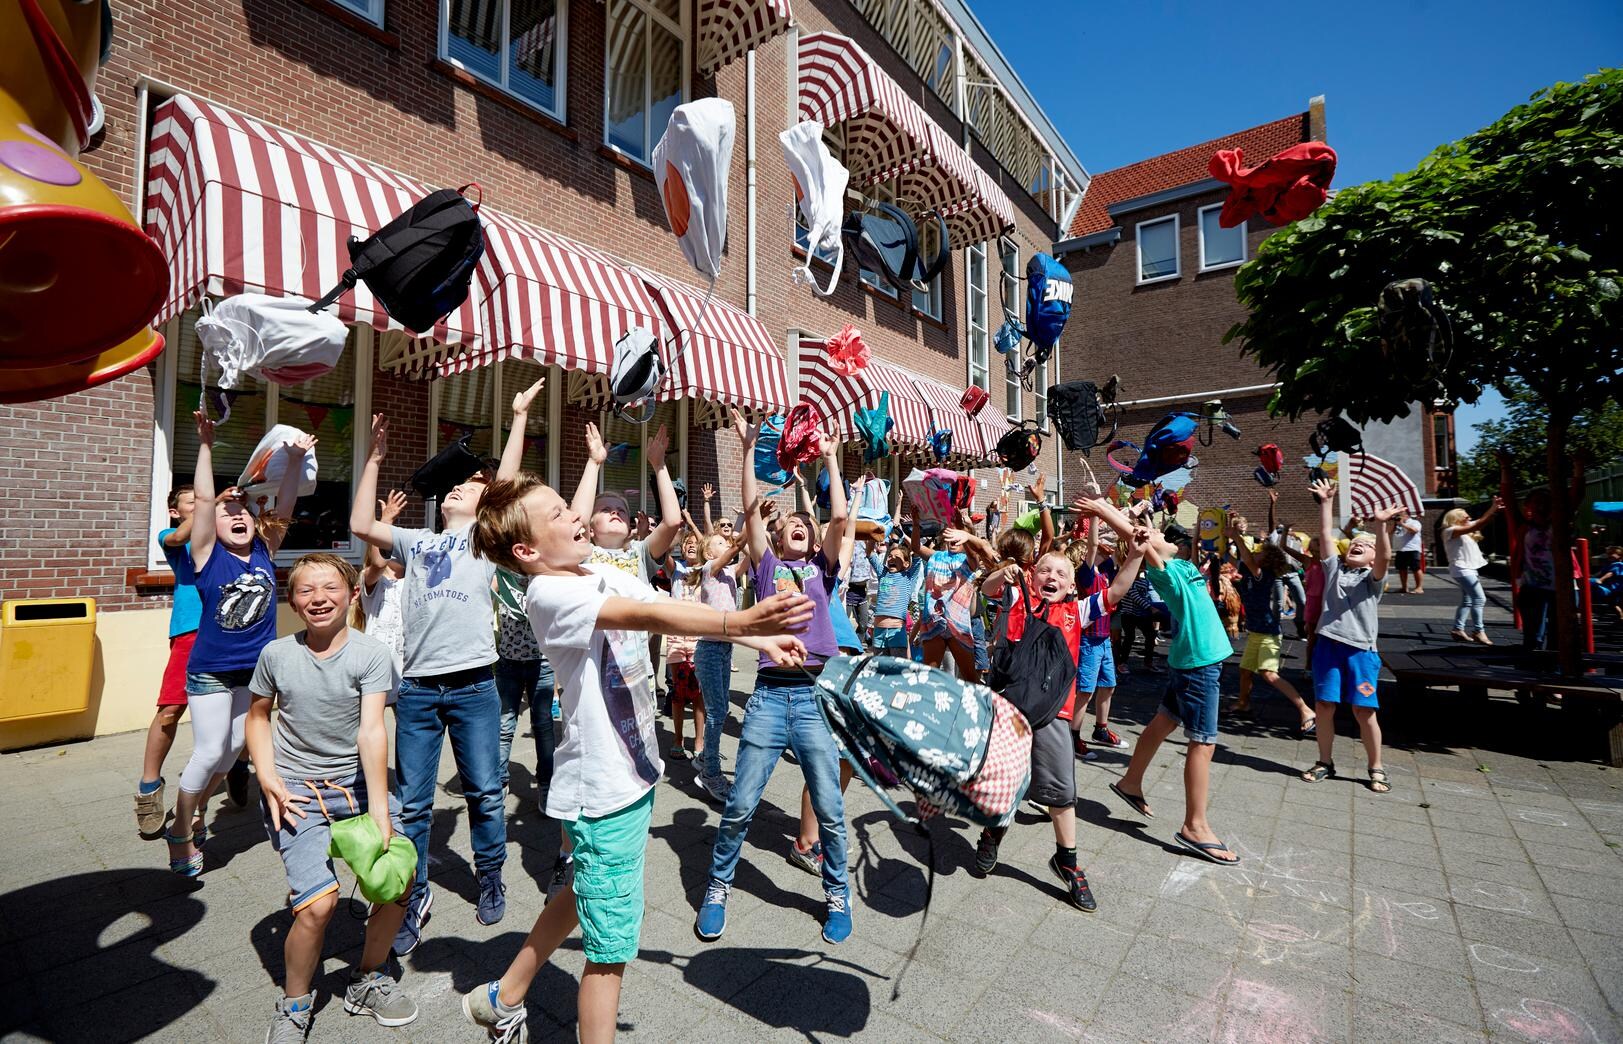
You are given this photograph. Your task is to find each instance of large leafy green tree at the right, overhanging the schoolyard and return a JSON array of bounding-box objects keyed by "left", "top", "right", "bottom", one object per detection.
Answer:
[{"left": 1227, "top": 70, "right": 1623, "bottom": 672}]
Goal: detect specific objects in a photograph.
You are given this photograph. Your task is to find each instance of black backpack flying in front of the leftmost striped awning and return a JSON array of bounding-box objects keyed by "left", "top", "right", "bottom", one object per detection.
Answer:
[{"left": 310, "top": 185, "right": 485, "bottom": 333}]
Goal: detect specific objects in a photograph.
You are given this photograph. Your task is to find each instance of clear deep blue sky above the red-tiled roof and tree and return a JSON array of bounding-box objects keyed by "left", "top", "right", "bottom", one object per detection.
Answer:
[{"left": 969, "top": 0, "right": 1623, "bottom": 451}]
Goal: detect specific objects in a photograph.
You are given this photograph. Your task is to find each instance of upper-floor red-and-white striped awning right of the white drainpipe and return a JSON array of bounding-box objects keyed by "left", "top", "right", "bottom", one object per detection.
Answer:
[{"left": 797, "top": 32, "right": 1014, "bottom": 245}]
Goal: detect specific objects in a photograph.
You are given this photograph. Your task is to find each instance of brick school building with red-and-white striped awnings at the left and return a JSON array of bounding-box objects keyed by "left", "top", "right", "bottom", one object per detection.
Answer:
[{"left": 0, "top": 0, "right": 1090, "bottom": 748}]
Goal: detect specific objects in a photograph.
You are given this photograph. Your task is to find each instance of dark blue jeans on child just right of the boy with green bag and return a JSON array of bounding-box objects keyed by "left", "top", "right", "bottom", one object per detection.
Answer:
[{"left": 394, "top": 667, "right": 506, "bottom": 885}]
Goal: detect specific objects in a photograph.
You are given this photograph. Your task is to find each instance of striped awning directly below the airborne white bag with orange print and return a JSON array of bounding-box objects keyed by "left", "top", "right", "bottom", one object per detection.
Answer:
[{"left": 635, "top": 268, "right": 790, "bottom": 421}]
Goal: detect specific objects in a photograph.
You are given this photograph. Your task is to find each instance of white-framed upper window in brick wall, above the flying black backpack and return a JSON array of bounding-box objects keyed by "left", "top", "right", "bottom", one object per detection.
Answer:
[{"left": 441, "top": 0, "right": 568, "bottom": 120}]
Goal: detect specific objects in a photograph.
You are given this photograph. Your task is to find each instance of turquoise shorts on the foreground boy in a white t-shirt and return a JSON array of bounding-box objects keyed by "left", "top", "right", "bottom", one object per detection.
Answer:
[{"left": 563, "top": 791, "right": 654, "bottom": 964}]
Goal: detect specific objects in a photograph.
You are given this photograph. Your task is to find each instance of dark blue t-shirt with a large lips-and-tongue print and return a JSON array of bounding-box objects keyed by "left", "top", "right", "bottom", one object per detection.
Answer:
[{"left": 187, "top": 537, "right": 276, "bottom": 674}]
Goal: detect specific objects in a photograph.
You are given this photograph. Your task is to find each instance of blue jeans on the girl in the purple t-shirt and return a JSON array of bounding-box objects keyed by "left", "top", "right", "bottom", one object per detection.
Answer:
[{"left": 711, "top": 684, "right": 846, "bottom": 893}]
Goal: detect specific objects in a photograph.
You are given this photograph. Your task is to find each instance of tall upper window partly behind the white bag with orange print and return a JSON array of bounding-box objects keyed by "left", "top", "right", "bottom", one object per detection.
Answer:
[{"left": 604, "top": 0, "right": 688, "bottom": 164}]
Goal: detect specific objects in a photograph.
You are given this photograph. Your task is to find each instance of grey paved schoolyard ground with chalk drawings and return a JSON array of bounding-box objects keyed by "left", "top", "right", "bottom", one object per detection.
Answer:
[{"left": 0, "top": 575, "right": 1623, "bottom": 1044}]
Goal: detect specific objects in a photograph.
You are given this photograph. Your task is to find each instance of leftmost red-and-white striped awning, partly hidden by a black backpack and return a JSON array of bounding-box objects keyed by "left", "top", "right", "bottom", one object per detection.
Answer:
[{"left": 143, "top": 94, "right": 479, "bottom": 344}]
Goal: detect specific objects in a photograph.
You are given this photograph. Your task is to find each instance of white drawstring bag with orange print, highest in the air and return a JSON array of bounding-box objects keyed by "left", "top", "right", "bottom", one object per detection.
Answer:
[{"left": 654, "top": 97, "right": 735, "bottom": 284}]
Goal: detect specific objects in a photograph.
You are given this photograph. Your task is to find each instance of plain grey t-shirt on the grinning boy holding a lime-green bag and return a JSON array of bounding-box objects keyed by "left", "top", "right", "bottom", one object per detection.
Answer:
[{"left": 248, "top": 630, "right": 396, "bottom": 779}]
